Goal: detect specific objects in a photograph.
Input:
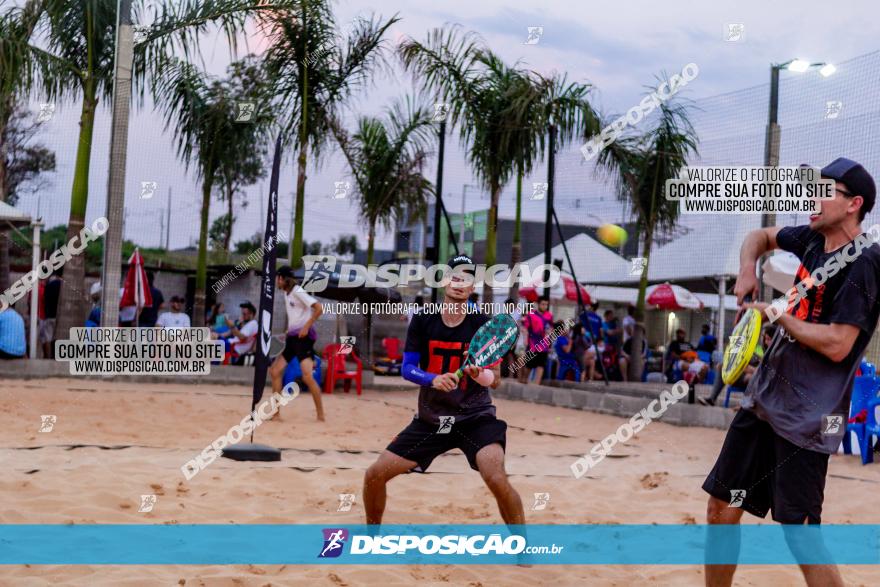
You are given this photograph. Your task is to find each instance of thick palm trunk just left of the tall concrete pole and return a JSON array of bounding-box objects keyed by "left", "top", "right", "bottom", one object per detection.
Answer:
[{"left": 55, "top": 82, "right": 97, "bottom": 340}]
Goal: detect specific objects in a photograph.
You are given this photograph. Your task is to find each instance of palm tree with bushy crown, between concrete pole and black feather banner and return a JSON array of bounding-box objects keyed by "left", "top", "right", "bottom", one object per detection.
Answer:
[{"left": 155, "top": 56, "right": 274, "bottom": 326}]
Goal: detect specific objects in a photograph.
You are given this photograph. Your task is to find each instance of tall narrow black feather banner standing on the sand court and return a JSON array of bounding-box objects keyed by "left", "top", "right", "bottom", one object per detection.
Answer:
[{"left": 251, "top": 136, "right": 281, "bottom": 411}]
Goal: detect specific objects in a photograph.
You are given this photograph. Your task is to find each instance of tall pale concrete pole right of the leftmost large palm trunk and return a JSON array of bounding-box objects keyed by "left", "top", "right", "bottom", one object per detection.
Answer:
[{"left": 101, "top": 0, "right": 134, "bottom": 326}]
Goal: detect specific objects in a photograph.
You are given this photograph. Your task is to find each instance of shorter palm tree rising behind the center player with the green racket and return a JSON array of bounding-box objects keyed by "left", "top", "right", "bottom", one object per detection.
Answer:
[{"left": 334, "top": 101, "right": 434, "bottom": 265}]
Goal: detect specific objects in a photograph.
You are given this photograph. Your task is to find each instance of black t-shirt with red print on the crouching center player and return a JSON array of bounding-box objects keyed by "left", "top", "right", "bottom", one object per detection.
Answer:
[{"left": 404, "top": 313, "right": 495, "bottom": 424}]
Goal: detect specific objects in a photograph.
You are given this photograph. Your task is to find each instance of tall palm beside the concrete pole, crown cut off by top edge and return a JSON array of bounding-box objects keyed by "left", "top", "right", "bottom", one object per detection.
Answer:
[{"left": 29, "top": 0, "right": 294, "bottom": 336}]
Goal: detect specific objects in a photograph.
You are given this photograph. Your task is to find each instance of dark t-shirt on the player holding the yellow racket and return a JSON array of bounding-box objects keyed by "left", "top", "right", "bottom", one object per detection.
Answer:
[{"left": 742, "top": 226, "right": 880, "bottom": 453}]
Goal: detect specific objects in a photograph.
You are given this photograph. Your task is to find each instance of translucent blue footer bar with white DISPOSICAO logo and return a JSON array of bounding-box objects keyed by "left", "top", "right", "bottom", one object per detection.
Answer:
[{"left": 0, "top": 524, "right": 880, "bottom": 565}]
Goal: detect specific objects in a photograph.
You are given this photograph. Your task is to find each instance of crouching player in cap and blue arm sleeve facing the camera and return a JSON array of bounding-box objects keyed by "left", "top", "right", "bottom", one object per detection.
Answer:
[{"left": 364, "top": 255, "right": 525, "bottom": 525}]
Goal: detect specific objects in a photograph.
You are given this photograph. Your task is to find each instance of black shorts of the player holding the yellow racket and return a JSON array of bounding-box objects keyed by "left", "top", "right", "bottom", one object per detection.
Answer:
[{"left": 703, "top": 409, "right": 830, "bottom": 524}]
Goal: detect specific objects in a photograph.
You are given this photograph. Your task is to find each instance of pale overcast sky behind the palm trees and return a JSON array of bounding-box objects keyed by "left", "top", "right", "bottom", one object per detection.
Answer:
[{"left": 20, "top": 0, "right": 878, "bottom": 253}]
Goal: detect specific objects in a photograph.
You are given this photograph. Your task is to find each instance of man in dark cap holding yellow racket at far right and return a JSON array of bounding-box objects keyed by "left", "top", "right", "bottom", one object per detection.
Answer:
[{"left": 703, "top": 158, "right": 880, "bottom": 587}]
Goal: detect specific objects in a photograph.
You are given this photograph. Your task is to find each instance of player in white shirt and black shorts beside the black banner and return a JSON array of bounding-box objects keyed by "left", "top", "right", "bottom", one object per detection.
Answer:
[{"left": 269, "top": 265, "right": 324, "bottom": 422}]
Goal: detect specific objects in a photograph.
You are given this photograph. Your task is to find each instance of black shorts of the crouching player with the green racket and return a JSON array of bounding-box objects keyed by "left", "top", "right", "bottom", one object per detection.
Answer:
[{"left": 387, "top": 415, "right": 507, "bottom": 473}]
